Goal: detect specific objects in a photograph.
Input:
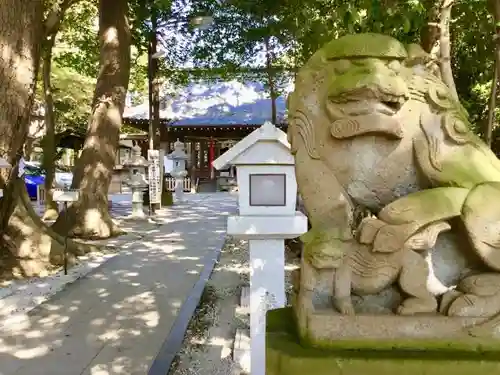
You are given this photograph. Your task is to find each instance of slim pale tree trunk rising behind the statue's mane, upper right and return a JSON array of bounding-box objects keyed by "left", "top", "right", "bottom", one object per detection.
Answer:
[{"left": 439, "top": 0, "right": 459, "bottom": 100}]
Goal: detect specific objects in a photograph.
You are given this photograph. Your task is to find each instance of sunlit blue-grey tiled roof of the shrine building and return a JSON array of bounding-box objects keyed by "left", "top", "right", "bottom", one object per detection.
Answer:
[{"left": 124, "top": 81, "right": 293, "bottom": 126}]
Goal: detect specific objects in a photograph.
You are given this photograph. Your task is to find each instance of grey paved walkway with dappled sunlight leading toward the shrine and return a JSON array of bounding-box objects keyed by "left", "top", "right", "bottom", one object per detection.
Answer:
[{"left": 0, "top": 193, "right": 236, "bottom": 375}]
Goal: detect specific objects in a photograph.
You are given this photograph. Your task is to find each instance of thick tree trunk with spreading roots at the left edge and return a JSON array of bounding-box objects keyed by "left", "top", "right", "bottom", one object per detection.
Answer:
[{"left": 0, "top": 0, "right": 90, "bottom": 276}]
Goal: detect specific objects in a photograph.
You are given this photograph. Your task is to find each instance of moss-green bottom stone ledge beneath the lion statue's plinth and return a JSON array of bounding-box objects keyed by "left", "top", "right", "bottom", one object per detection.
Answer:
[{"left": 266, "top": 308, "right": 500, "bottom": 375}]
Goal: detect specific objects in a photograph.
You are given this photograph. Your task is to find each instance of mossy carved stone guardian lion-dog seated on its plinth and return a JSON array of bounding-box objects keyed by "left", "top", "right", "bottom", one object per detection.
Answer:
[{"left": 288, "top": 34, "right": 500, "bottom": 326}]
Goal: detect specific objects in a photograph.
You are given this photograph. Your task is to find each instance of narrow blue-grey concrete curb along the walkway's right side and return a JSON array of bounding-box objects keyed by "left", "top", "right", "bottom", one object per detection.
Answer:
[{"left": 148, "top": 234, "right": 226, "bottom": 375}]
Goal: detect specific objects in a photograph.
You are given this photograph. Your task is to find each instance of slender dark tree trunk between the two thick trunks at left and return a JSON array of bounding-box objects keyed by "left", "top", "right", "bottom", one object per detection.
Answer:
[{"left": 42, "top": 33, "right": 58, "bottom": 220}]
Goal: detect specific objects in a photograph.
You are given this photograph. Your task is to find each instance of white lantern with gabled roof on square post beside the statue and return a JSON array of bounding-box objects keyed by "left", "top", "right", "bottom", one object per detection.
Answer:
[{"left": 213, "top": 122, "right": 307, "bottom": 375}]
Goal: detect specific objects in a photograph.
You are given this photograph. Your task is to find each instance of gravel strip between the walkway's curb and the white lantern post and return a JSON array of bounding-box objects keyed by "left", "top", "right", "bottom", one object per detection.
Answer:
[{"left": 169, "top": 237, "right": 299, "bottom": 375}]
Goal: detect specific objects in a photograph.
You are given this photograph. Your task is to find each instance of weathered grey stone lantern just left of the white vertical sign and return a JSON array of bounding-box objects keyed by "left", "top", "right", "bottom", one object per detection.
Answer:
[{"left": 123, "top": 145, "right": 149, "bottom": 219}]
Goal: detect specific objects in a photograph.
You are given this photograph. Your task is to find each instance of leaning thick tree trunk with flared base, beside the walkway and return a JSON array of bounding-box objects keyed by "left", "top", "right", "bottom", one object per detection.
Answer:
[{"left": 53, "top": 0, "right": 130, "bottom": 238}]
